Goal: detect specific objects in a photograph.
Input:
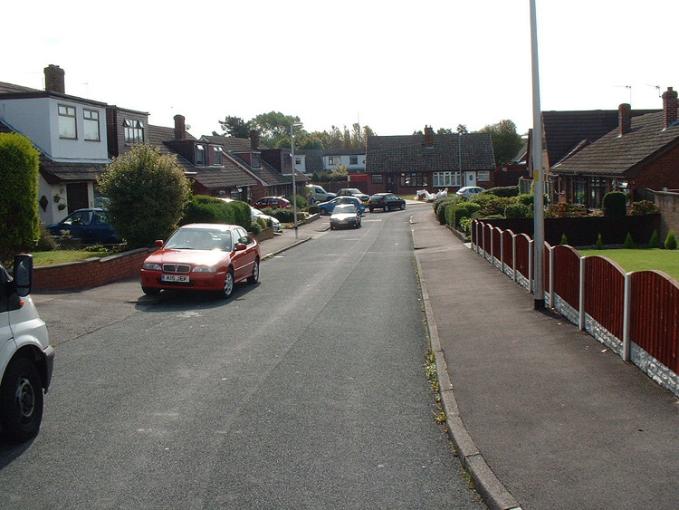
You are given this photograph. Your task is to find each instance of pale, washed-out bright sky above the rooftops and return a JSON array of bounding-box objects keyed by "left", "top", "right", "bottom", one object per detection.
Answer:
[{"left": 0, "top": 0, "right": 679, "bottom": 136}]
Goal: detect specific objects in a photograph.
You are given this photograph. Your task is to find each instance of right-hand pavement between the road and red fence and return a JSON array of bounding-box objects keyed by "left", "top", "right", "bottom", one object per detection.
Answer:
[{"left": 413, "top": 208, "right": 679, "bottom": 509}]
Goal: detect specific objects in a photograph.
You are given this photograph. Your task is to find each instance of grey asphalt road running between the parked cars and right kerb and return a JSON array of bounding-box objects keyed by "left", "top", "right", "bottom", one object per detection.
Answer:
[{"left": 0, "top": 205, "right": 482, "bottom": 509}]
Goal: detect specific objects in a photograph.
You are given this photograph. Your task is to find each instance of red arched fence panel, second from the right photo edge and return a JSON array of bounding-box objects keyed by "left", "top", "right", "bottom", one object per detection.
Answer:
[{"left": 585, "top": 256, "right": 625, "bottom": 339}]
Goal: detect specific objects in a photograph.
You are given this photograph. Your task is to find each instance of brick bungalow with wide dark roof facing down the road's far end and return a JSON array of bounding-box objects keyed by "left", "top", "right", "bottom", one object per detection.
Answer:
[{"left": 365, "top": 126, "right": 495, "bottom": 195}]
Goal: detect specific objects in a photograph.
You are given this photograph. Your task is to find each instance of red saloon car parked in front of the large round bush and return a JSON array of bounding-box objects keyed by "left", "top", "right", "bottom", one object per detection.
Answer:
[{"left": 140, "top": 223, "right": 260, "bottom": 298}]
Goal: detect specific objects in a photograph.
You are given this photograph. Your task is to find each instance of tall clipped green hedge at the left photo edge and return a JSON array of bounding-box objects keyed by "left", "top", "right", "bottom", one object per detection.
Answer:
[{"left": 0, "top": 133, "right": 40, "bottom": 263}]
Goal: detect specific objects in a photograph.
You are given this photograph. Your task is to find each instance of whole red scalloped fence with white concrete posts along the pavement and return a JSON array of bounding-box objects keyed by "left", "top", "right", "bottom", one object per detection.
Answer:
[{"left": 472, "top": 220, "right": 679, "bottom": 396}]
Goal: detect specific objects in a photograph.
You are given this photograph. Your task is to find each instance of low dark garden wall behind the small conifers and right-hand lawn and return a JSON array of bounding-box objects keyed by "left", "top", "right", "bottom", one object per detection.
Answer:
[{"left": 481, "top": 214, "right": 660, "bottom": 246}]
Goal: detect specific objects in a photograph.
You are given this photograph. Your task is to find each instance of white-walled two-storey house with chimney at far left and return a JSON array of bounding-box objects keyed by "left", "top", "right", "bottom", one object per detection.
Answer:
[{"left": 0, "top": 65, "right": 110, "bottom": 224}]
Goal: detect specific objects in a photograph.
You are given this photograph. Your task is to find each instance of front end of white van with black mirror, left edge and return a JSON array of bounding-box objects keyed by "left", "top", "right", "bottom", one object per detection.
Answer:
[{"left": 0, "top": 255, "right": 54, "bottom": 441}]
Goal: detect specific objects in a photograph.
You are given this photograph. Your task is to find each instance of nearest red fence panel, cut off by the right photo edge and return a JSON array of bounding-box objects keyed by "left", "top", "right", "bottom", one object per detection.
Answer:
[{"left": 630, "top": 271, "right": 679, "bottom": 373}]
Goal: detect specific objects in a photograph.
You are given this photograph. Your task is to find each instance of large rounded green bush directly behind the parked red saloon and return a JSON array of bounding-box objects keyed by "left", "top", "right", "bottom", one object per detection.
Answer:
[{"left": 99, "top": 145, "right": 190, "bottom": 248}]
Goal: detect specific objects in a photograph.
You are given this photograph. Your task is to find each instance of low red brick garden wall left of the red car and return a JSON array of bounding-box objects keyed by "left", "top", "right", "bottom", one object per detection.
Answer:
[{"left": 33, "top": 248, "right": 153, "bottom": 290}]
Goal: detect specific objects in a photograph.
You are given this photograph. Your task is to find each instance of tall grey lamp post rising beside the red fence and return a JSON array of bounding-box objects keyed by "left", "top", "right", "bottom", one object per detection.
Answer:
[{"left": 529, "top": 0, "right": 545, "bottom": 310}]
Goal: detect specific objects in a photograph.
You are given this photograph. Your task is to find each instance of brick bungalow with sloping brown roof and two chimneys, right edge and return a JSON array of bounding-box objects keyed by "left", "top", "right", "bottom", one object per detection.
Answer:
[{"left": 552, "top": 87, "right": 679, "bottom": 208}]
